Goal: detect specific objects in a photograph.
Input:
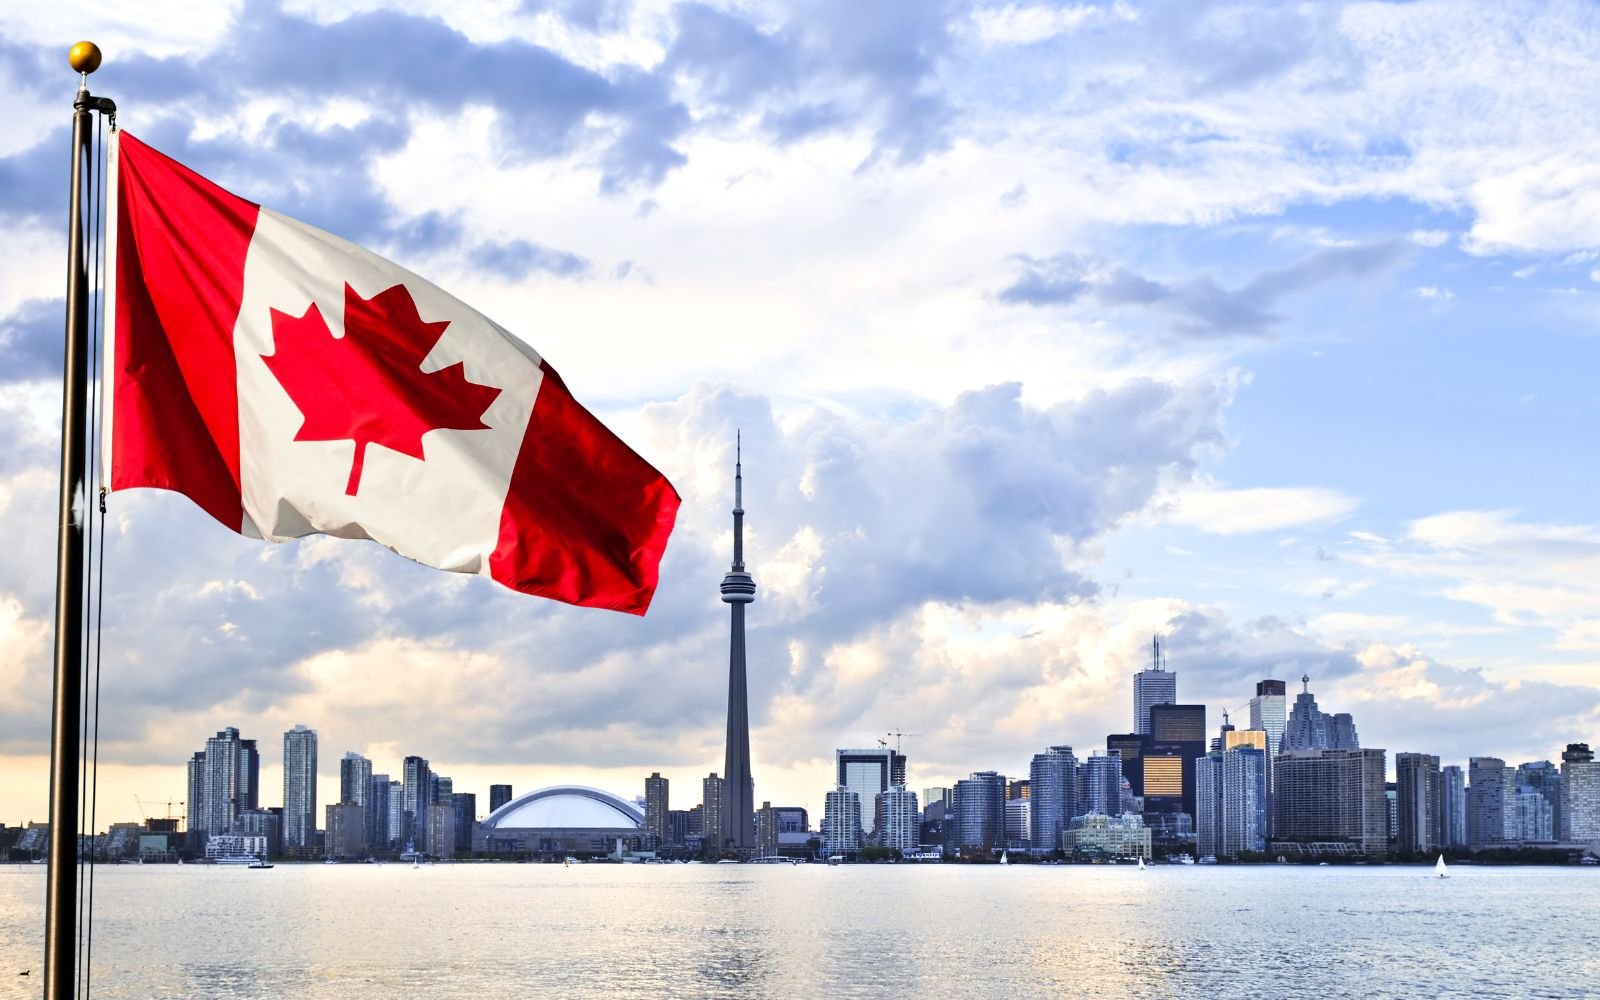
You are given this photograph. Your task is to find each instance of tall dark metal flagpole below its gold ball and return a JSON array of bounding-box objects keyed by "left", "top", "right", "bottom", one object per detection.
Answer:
[{"left": 45, "top": 86, "right": 94, "bottom": 1000}]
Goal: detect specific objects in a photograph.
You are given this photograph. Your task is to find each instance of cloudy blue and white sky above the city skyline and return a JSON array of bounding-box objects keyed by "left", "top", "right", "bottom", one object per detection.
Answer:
[{"left": 0, "top": 0, "right": 1600, "bottom": 826}]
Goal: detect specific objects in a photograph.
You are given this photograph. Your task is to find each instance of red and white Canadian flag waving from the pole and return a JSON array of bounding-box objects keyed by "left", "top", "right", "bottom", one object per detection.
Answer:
[{"left": 106, "top": 133, "right": 678, "bottom": 614}]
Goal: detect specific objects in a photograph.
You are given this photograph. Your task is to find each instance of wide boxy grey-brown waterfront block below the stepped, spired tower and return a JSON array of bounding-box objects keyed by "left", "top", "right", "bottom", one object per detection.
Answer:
[{"left": 1272, "top": 749, "right": 1389, "bottom": 856}]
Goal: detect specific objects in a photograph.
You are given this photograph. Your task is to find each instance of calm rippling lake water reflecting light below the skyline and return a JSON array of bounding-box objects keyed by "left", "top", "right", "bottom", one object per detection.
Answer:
[{"left": 0, "top": 864, "right": 1600, "bottom": 1000}]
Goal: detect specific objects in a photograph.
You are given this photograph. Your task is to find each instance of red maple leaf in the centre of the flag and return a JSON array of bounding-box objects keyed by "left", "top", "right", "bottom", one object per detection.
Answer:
[{"left": 261, "top": 285, "right": 501, "bottom": 496}]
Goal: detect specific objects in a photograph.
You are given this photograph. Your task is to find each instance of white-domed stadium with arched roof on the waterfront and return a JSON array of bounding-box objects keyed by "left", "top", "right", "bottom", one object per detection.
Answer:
[{"left": 472, "top": 784, "right": 640, "bottom": 858}]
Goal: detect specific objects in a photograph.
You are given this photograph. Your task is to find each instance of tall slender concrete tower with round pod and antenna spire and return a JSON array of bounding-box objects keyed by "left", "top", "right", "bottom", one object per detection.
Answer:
[{"left": 720, "top": 438, "right": 755, "bottom": 851}]
